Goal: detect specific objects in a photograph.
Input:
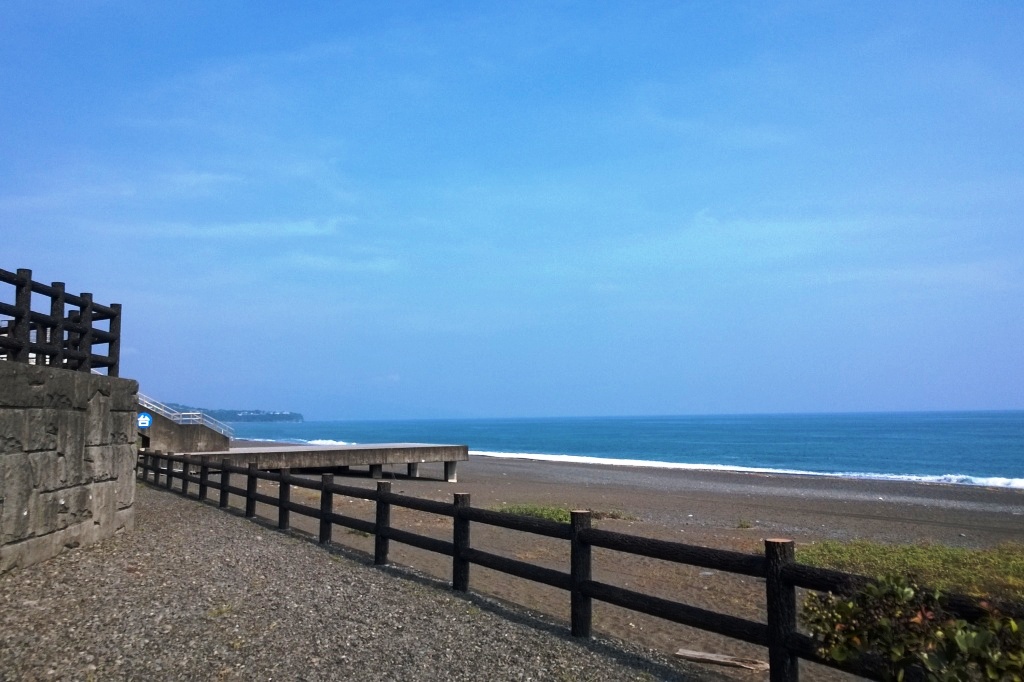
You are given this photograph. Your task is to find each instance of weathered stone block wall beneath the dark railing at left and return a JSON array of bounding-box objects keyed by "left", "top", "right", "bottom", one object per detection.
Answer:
[{"left": 0, "top": 361, "right": 138, "bottom": 573}]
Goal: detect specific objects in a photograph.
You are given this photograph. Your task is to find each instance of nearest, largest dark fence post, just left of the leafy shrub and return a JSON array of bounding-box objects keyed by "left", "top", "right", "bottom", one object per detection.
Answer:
[{"left": 765, "top": 540, "right": 800, "bottom": 682}]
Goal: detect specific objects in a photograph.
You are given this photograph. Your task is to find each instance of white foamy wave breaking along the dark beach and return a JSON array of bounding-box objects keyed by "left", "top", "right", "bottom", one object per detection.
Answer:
[{"left": 469, "top": 450, "right": 1024, "bottom": 489}]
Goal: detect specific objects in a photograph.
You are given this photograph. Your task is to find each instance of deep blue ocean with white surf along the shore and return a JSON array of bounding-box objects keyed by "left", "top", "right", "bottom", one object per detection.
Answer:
[{"left": 232, "top": 412, "right": 1024, "bottom": 488}]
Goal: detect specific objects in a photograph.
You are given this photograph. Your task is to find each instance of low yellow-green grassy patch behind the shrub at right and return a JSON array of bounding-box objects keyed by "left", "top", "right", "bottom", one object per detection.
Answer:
[{"left": 797, "top": 541, "right": 1024, "bottom": 601}]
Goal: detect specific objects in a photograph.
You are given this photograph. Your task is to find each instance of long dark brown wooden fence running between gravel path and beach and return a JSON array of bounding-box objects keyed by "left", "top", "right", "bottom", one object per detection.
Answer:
[{"left": 137, "top": 452, "right": 1007, "bottom": 682}]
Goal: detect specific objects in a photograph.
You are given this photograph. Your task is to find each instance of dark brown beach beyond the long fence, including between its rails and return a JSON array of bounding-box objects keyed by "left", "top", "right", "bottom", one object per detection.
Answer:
[{"left": 224, "top": 443, "right": 1024, "bottom": 680}]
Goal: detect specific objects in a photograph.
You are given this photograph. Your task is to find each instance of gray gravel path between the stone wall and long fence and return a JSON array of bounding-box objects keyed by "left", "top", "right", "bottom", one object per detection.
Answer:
[{"left": 0, "top": 485, "right": 717, "bottom": 681}]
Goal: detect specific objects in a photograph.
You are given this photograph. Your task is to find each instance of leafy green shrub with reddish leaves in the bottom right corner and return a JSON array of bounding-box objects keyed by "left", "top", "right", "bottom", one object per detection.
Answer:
[{"left": 803, "top": 577, "right": 1024, "bottom": 682}]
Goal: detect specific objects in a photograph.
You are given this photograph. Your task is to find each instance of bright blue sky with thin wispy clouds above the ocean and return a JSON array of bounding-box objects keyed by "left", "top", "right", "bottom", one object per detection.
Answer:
[{"left": 0, "top": 0, "right": 1024, "bottom": 419}]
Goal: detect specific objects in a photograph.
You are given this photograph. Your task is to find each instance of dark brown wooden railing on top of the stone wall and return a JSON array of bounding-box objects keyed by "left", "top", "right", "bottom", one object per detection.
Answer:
[{"left": 0, "top": 269, "right": 121, "bottom": 377}]
